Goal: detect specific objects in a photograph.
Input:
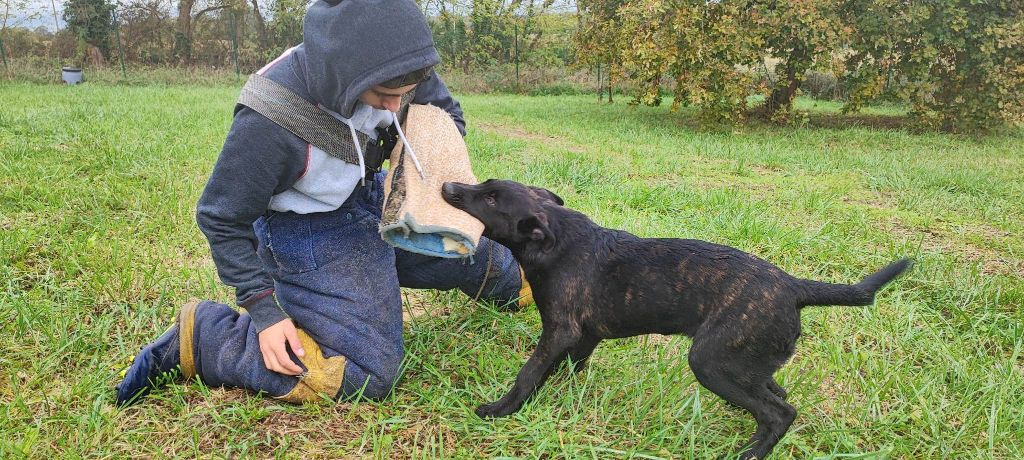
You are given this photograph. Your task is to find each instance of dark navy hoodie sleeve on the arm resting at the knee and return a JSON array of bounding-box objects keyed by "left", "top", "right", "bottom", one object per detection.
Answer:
[{"left": 196, "top": 108, "right": 306, "bottom": 331}]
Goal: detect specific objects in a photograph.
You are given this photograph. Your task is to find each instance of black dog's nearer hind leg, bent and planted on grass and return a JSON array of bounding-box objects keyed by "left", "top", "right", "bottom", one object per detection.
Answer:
[{"left": 689, "top": 337, "right": 797, "bottom": 460}]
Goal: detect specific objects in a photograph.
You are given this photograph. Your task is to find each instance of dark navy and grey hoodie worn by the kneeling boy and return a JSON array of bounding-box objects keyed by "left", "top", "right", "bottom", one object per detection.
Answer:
[{"left": 196, "top": 0, "right": 465, "bottom": 331}]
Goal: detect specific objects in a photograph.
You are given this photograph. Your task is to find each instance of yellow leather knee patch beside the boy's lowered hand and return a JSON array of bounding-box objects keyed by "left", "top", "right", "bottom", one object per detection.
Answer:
[{"left": 275, "top": 329, "right": 346, "bottom": 404}]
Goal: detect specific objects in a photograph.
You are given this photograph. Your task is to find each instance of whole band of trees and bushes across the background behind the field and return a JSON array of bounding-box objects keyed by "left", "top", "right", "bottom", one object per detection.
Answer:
[{"left": 0, "top": 0, "right": 1024, "bottom": 128}]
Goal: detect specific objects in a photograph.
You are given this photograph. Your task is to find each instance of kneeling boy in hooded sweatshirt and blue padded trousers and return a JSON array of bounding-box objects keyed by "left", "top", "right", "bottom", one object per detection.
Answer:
[{"left": 117, "top": 0, "right": 528, "bottom": 405}]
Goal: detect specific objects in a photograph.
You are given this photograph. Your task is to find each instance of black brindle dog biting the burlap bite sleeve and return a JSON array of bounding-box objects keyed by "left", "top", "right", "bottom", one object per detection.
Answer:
[{"left": 441, "top": 180, "right": 910, "bottom": 459}]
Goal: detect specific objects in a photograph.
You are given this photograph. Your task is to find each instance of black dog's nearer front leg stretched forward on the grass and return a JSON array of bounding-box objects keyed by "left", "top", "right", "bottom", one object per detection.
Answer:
[{"left": 476, "top": 326, "right": 583, "bottom": 418}]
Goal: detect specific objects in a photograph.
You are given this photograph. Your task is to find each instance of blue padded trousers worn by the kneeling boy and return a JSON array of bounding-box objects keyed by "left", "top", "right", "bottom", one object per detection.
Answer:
[{"left": 186, "top": 172, "right": 521, "bottom": 399}]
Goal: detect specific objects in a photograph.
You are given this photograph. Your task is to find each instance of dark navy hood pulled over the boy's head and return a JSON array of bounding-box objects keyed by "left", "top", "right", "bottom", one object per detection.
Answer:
[{"left": 303, "top": 0, "right": 440, "bottom": 118}]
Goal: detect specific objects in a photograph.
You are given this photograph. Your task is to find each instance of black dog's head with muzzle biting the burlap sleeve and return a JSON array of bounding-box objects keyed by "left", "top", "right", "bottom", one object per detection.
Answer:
[{"left": 441, "top": 179, "right": 564, "bottom": 251}]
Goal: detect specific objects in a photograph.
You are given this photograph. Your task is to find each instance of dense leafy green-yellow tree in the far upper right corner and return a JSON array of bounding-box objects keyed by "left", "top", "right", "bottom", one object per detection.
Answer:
[{"left": 844, "top": 0, "right": 1024, "bottom": 132}]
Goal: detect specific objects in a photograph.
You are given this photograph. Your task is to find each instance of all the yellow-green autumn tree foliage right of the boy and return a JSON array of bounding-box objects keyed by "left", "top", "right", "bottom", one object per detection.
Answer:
[{"left": 575, "top": 0, "right": 1024, "bottom": 131}]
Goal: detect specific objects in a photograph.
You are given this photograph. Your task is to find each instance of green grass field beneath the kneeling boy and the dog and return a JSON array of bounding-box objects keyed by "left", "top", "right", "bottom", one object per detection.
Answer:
[{"left": 0, "top": 82, "right": 1024, "bottom": 459}]
